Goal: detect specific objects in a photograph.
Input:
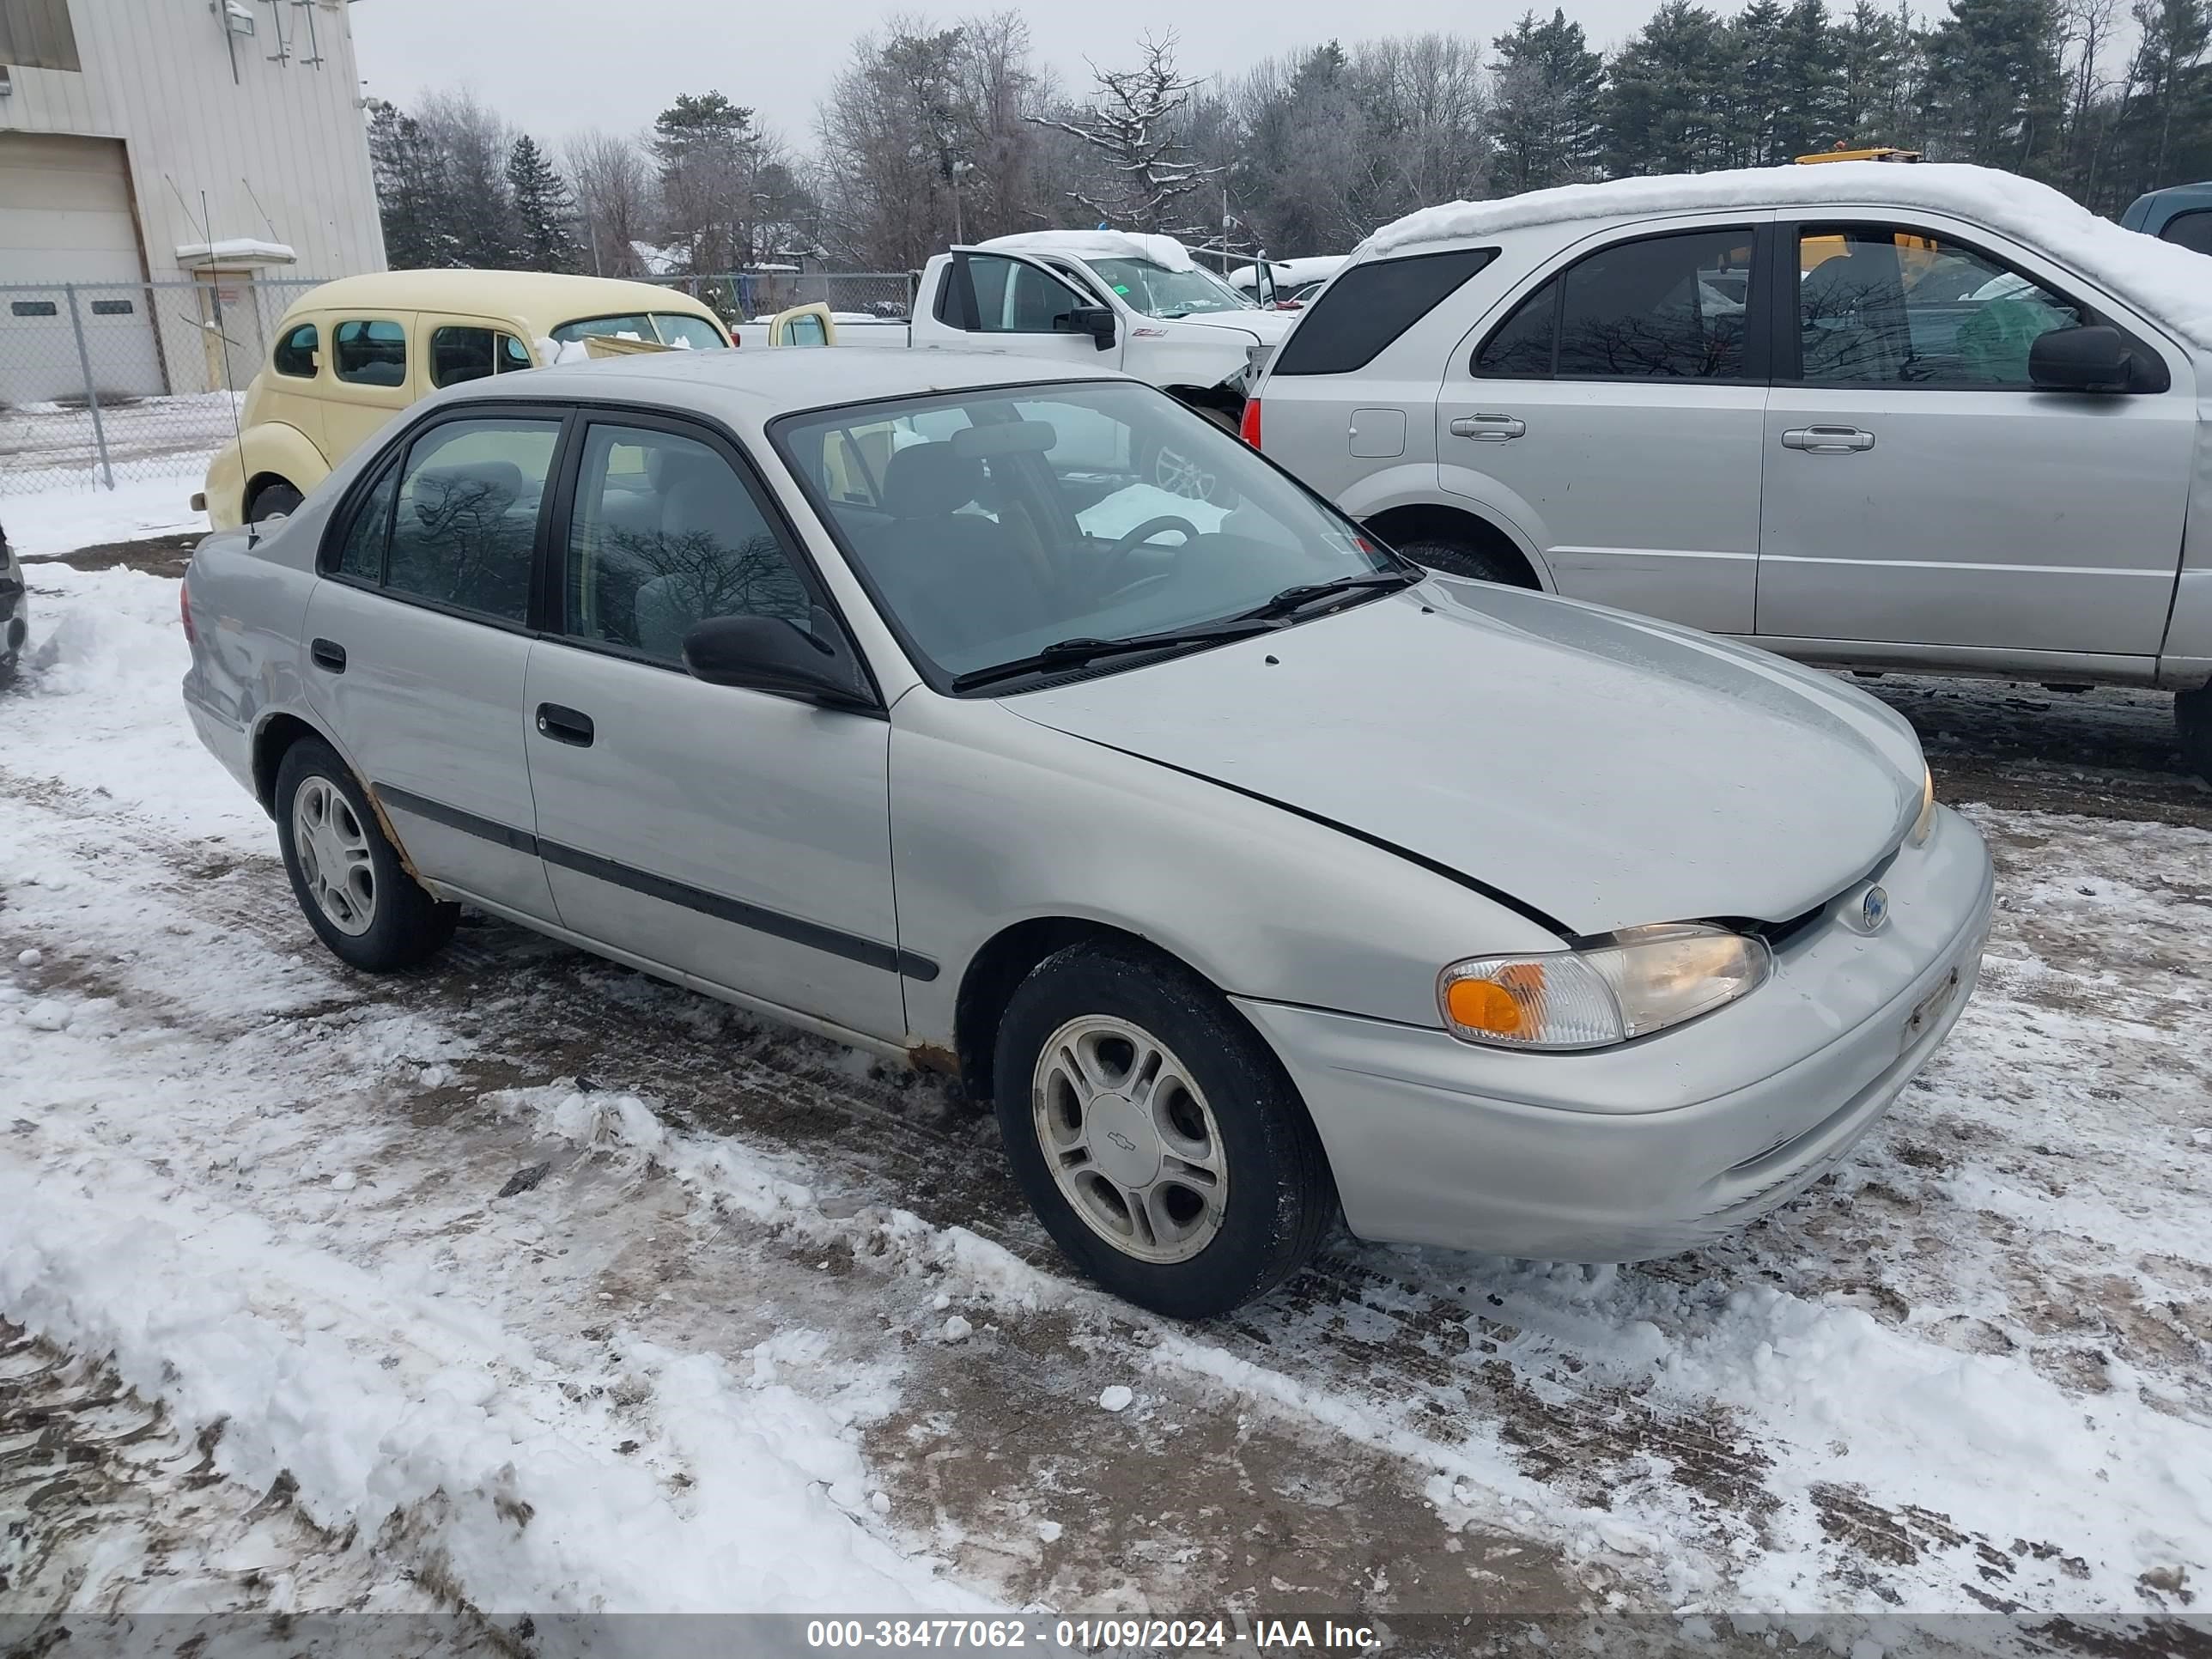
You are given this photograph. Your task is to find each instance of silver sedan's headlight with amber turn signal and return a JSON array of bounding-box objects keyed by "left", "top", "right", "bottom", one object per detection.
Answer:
[{"left": 1436, "top": 922, "right": 1774, "bottom": 1048}]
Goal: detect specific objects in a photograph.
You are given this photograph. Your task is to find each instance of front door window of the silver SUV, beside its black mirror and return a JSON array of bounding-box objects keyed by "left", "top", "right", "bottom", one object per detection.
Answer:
[{"left": 1798, "top": 226, "right": 2088, "bottom": 389}]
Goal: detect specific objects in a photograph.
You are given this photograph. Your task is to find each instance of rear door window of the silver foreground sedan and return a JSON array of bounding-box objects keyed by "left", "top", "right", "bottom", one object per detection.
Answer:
[{"left": 385, "top": 418, "right": 560, "bottom": 622}]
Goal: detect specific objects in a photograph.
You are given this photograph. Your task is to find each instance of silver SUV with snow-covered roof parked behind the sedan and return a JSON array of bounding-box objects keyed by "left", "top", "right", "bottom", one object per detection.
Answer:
[{"left": 1245, "top": 161, "right": 2212, "bottom": 768}]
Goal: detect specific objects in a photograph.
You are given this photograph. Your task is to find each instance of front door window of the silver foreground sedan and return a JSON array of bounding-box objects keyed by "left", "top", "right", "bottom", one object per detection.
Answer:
[{"left": 564, "top": 425, "right": 814, "bottom": 664}]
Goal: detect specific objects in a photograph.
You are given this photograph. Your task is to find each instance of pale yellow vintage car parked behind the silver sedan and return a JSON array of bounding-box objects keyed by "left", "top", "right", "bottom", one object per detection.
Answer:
[{"left": 192, "top": 270, "right": 730, "bottom": 529}]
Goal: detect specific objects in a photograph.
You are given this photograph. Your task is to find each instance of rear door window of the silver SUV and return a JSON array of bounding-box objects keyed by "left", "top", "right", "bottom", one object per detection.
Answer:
[{"left": 1471, "top": 228, "right": 1752, "bottom": 380}]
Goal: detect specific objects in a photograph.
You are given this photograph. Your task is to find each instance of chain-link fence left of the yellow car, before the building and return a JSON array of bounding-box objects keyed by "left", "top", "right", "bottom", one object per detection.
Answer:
[{"left": 0, "top": 276, "right": 316, "bottom": 495}]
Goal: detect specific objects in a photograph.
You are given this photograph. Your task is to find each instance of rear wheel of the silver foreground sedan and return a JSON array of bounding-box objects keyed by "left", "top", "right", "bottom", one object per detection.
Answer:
[{"left": 276, "top": 737, "right": 460, "bottom": 973}]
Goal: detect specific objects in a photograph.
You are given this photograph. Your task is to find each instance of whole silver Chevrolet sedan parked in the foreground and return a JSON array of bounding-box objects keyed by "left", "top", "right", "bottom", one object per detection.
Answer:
[{"left": 184, "top": 352, "right": 1990, "bottom": 1316}]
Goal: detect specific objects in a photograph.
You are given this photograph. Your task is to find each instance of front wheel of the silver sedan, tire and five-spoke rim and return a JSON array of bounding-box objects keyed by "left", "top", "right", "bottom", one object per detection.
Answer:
[{"left": 994, "top": 942, "right": 1336, "bottom": 1318}]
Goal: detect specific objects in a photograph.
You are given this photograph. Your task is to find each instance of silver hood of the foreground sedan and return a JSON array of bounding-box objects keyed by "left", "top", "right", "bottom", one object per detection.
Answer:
[{"left": 1005, "top": 577, "right": 1923, "bottom": 933}]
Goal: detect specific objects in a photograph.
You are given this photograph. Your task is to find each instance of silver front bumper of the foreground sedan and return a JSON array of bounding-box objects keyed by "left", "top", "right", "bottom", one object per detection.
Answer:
[{"left": 1237, "top": 810, "right": 1993, "bottom": 1261}]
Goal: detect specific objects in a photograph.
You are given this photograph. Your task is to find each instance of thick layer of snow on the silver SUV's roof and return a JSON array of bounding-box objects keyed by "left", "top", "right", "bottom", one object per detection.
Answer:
[{"left": 1358, "top": 161, "right": 2212, "bottom": 347}]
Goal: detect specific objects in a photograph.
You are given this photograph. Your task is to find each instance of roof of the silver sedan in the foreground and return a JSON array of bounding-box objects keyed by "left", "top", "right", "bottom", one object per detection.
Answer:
[{"left": 445, "top": 345, "right": 1130, "bottom": 429}]
